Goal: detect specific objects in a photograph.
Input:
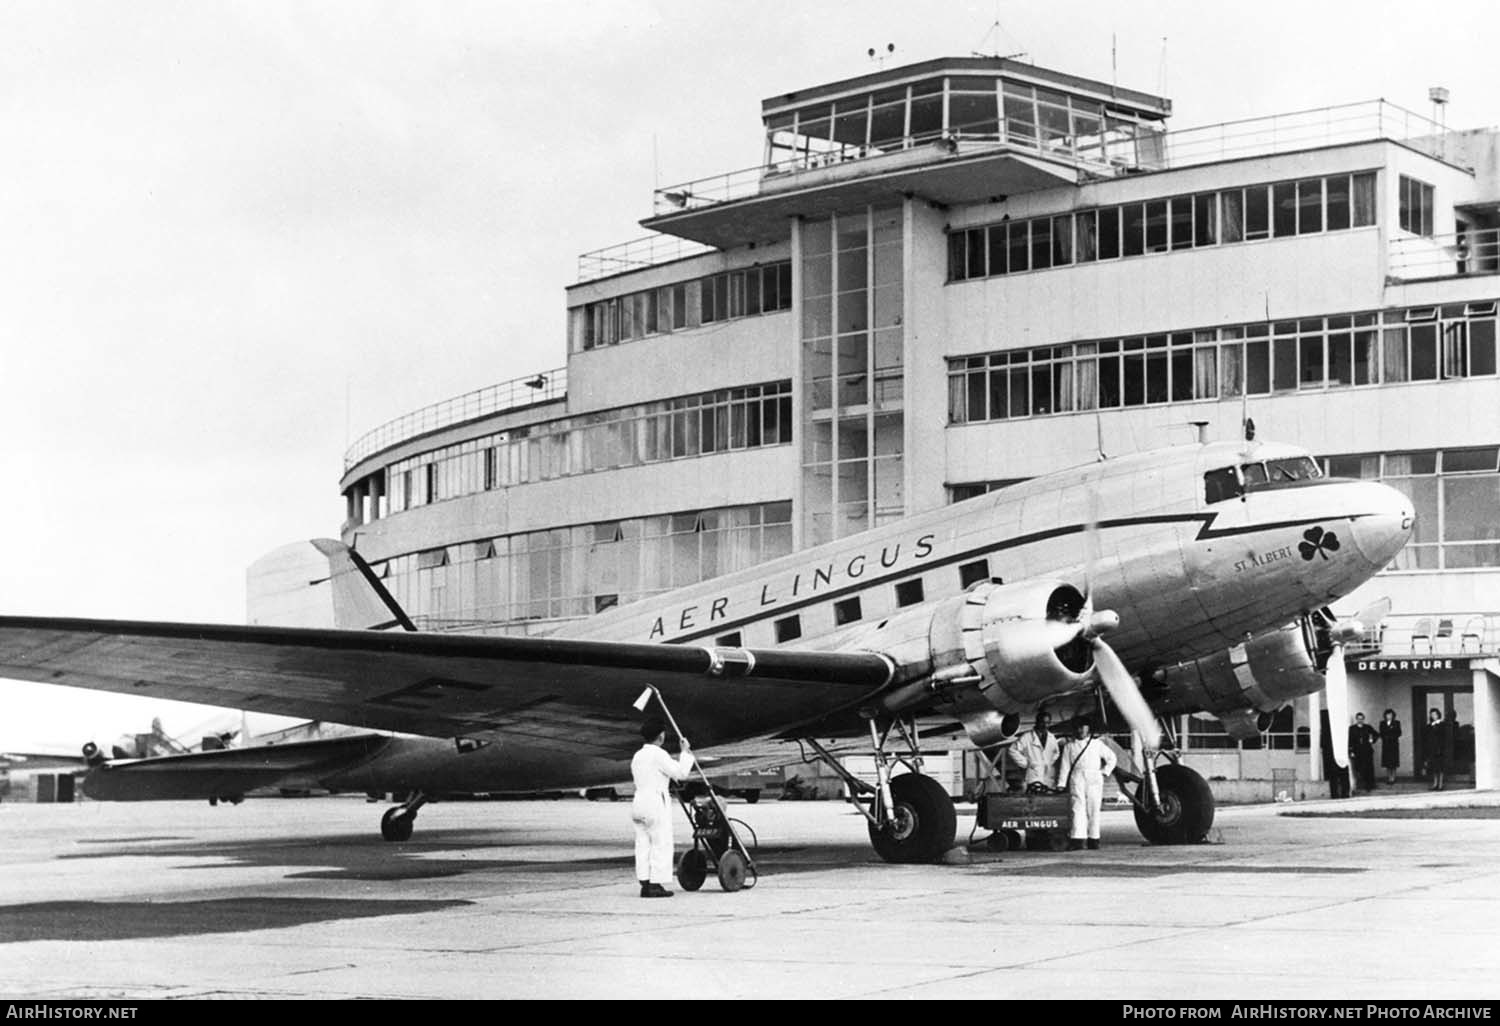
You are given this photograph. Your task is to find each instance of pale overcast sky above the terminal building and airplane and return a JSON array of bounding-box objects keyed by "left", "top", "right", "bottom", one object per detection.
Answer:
[{"left": 0, "top": 0, "right": 1500, "bottom": 750}]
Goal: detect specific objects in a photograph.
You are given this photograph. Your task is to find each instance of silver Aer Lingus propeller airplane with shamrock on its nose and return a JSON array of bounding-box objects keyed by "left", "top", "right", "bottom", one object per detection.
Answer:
[{"left": 0, "top": 441, "right": 1413, "bottom": 863}]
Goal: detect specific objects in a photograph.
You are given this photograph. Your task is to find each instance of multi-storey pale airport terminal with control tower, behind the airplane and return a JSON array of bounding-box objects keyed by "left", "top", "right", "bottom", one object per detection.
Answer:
[{"left": 249, "top": 57, "right": 1500, "bottom": 786}]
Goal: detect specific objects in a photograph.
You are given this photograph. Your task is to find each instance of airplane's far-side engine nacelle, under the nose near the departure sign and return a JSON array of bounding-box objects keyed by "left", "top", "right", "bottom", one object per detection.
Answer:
[{"left": 1152, "top": 621, "right": 1323, "bottom": 723}]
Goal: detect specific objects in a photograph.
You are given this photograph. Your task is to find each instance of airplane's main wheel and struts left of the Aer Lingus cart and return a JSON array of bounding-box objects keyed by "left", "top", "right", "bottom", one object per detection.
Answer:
[{"left": 807, "top": 719, "right": 959, "bottom": 863}]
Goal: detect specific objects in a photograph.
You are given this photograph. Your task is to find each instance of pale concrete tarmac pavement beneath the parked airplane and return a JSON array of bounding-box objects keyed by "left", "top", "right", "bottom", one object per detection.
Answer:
[{"left": 0, "top": 791, "right": 1500, "bottom": 1002}]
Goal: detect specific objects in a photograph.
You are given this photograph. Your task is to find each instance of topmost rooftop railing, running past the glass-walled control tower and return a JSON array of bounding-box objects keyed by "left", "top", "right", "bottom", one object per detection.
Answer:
[{"left": 654, "top": 101, "right": 1443, "bottom": 215}]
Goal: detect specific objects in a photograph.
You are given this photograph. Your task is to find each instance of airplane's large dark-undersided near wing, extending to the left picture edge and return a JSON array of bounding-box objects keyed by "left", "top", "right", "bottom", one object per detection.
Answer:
[{"left": 0, "top": 617, "right": 893, "bottom": 758}]
